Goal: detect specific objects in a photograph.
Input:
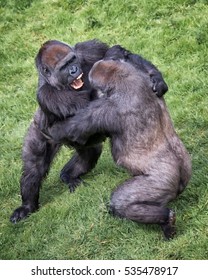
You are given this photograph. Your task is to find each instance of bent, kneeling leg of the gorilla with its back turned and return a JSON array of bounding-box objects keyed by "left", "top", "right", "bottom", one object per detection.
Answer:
[{"left": 110, "top": 175, "right": 175, "bottom": 239}]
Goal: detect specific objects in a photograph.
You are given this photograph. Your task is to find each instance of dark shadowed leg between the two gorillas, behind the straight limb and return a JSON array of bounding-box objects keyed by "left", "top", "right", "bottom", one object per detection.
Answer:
[{"left": 60, "top": 144, "right": 102, "bottom": 192}]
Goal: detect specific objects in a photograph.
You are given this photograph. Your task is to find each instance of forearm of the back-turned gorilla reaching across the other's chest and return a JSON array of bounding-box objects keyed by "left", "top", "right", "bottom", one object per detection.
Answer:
[{"left": 48, "top": 97, "right": 120, "bottom": 145}]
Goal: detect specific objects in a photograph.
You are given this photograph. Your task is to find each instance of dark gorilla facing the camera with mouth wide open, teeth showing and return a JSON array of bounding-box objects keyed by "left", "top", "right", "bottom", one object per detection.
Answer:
[{"left": 10, "top": 40, "right": 167, "bottom": 223}]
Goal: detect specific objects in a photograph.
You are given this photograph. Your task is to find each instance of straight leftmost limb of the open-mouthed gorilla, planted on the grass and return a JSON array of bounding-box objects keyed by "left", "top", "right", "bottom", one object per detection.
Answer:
[{"left": 10, "top": 123, "right": 60, "bottom": 223}]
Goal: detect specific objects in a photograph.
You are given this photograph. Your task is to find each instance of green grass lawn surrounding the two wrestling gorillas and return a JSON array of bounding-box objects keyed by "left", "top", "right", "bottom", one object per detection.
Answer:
[{"left": 0, "top": 0, "right": 208, "bottom": 260}]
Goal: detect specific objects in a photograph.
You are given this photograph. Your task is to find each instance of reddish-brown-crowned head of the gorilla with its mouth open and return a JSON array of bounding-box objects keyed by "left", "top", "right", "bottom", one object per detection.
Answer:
[{"left": 35, "top": 40, "right": 84, "bottom": 90}]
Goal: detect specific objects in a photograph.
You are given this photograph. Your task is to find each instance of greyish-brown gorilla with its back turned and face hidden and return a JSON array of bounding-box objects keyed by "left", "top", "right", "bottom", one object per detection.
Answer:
[{"left": 50, "top": 47, "right": 191, "bottom": 239}]
